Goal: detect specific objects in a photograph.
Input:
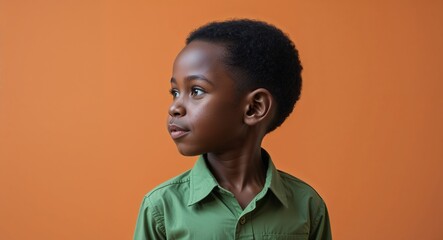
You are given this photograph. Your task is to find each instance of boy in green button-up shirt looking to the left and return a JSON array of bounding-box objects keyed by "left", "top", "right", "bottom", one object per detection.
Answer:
[{"left": 134, "top": 19, "right": 331, "bottom": 240}]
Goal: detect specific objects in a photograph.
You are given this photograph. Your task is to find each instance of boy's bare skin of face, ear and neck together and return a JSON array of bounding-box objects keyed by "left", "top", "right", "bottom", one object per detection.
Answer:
[{"left": 167, "top": 41, "right": 276, "bottom": 208}]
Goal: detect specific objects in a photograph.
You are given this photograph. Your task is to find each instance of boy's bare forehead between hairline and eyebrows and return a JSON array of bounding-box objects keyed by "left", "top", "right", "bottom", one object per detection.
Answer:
[{"left": 173, "top": 41, "right": 231, "bottom": 75}]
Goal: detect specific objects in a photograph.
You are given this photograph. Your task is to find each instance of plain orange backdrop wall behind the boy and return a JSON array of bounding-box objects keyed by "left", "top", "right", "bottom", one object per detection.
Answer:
[{"left": 0, "top": 0, "right": 443, "bottom": 240}]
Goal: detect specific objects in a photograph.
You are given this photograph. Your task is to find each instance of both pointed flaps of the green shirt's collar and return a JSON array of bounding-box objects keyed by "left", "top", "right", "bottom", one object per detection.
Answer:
[{"left": 188, "top": 149, "right": 288, "bottom": 207}]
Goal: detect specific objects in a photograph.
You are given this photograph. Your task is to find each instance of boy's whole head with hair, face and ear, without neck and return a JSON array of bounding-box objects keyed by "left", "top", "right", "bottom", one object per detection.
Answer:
[{"left": 168, "top": 20, "right": 302, "bottom": 155}]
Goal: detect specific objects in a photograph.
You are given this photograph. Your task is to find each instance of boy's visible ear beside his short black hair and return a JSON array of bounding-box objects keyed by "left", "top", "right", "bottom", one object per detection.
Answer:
[{"left": 244, "top": 88, "right": 274, "bottom": 126}]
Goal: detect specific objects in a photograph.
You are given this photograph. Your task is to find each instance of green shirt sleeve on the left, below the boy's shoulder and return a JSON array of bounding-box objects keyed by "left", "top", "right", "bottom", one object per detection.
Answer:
[{"left": 134, "top": 196, "right": 166, "bottom": 240}]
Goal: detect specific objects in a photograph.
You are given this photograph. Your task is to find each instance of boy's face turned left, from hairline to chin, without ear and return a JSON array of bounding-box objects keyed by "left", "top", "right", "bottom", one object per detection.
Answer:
[{"left": 167, "top": 41, "right": 247, "bottom": 156}]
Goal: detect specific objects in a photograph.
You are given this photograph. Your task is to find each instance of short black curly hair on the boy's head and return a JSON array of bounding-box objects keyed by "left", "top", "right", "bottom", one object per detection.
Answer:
[{"left": 186, "top": 19, "right": 302, "bottom": 133}]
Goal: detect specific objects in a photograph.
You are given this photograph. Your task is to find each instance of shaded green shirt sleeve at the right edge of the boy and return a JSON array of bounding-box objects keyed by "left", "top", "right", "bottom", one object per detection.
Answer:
[{"left": 309, "top": 201, "right": 332, "bottom": 240}]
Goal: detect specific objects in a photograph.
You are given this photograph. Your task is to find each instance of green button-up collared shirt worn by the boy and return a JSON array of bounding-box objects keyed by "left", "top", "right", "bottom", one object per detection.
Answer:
[{"left": 134, "top": 151, "right": 332, "bottom": 240}]
